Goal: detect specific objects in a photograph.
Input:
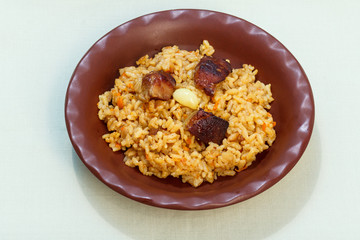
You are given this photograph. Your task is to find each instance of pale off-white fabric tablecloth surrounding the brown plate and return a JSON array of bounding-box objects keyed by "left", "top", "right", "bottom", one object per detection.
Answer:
[{"left": 0, "top": 0, "right": 360, "bottom": 240}]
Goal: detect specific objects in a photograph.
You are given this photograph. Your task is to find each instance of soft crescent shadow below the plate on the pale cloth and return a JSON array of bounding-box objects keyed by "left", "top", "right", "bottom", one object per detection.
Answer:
[{"left": 73, "top": 124, "right": 321, "bottom": 240}]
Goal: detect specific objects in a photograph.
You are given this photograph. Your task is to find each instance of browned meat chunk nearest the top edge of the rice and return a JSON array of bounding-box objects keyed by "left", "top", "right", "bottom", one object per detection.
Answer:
[{"left": 194, "top": 56, "right": 232, "bottom": 96}]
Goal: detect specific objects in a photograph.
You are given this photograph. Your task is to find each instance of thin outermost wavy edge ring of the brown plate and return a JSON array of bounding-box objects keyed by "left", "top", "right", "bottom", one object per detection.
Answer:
[{"left": 64, "top": 9, "right": 315, "bottom": 210}]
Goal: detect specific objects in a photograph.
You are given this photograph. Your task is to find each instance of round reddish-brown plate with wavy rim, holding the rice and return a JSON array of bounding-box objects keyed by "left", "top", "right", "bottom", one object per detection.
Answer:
[{"left": 65, "top": 10, "right": 314, "bottom": 209}]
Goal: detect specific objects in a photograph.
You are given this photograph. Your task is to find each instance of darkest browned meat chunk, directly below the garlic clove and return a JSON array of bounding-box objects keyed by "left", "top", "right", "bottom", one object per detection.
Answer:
[{"left": 187, "top": 108, "right": 229, "bottom": 145}]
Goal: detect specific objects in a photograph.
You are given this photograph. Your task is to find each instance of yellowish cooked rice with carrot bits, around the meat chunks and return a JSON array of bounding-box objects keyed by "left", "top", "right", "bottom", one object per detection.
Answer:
[{"left": 98, "top": 40, "right": 276, "bottom": 187}]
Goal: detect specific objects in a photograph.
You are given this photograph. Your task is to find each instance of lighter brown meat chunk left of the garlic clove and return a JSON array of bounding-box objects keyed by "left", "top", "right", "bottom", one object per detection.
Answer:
[{"left": 141, "top": 71, "right": 176, "bottom": 100}]
